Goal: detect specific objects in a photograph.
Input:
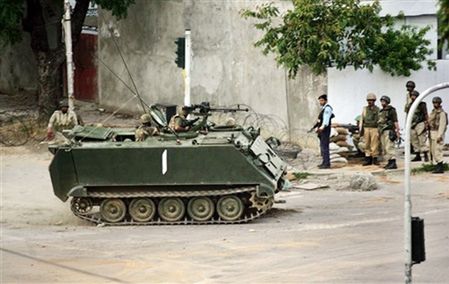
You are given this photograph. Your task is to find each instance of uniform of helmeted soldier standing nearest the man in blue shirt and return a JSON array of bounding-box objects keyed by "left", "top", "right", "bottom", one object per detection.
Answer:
[{"left": 361, "top": 106, "right": 379, "bottom": 158}]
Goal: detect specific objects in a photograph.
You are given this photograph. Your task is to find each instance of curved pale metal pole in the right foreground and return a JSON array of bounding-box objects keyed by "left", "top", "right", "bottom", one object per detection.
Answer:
[{"left": 404, "top": 82, "right": 449, "bottom": 284}]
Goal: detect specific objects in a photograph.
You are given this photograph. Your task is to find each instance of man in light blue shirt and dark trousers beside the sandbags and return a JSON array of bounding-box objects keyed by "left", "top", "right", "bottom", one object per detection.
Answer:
[{"left": 314, "top": 94, "right": 334, "bottom": 169}]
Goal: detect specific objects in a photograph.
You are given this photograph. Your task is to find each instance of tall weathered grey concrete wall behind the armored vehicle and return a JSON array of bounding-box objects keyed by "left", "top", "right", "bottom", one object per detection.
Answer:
[{"left": 98, "top": 0, "right": 326, "bottom": 143}]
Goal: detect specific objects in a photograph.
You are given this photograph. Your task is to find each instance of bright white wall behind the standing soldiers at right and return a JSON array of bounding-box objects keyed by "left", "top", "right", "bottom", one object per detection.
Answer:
[{"left": 328, "top": 60, "right": 449, "bottom": 143}]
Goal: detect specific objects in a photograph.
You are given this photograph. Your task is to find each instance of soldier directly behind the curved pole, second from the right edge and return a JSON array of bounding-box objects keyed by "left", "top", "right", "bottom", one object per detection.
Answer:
[{"left": 410, "top": 91, "right": 429, "bottom": 162}]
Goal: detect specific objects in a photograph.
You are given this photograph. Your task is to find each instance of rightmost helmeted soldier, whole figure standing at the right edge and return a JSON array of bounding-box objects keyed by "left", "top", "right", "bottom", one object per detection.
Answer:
[{"left": 429, "top": 97, "right": 448, "bottom": 174}]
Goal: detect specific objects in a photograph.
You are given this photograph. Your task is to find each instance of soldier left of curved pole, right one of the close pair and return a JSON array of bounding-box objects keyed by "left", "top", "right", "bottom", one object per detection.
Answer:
[{"left": 378, "top": 96, "right": 400, "bottom": 170}]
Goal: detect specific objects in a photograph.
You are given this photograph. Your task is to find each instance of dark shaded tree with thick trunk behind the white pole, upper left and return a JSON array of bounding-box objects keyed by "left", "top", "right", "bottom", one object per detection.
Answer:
[{"left": 0, "top": 0, "right": 135, "bottom": 121}]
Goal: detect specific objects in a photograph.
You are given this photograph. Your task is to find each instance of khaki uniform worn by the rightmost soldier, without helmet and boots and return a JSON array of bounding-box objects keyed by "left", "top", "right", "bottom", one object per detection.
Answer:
[{"left": 429, "top": 108, "right": 448, "bottom": 164}]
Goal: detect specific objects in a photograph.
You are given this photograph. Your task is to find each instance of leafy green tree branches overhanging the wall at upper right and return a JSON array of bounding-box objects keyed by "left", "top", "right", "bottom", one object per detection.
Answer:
[{"left": 242, "top": 0, "right": 435, "bottom": 77}]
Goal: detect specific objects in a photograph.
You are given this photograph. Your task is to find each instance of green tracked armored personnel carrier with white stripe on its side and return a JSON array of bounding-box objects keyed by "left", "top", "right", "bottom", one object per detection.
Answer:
[{"left": 49, "top": 104, "right": 286, "bottom": 225}]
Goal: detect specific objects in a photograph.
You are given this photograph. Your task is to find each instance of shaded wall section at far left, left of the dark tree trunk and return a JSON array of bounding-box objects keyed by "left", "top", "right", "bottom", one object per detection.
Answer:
[{"left": 0, "top": 33, "right": 37, "bottom": 93}]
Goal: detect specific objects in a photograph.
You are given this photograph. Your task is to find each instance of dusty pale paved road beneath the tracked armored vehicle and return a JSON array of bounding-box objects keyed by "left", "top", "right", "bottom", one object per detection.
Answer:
[{"left": 0, "top": 148, "right": 449, "bottom": 283}]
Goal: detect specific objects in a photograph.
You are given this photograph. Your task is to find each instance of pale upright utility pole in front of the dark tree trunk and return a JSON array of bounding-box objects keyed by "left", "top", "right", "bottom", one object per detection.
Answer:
[{"left": 62, "top": 0, "right": 74, "bottom": 111}]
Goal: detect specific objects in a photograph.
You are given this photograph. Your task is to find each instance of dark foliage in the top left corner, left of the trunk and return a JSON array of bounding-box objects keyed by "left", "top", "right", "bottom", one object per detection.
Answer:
[{"left": 0, "top": 0, "right": 25, "bottom": 45}]
